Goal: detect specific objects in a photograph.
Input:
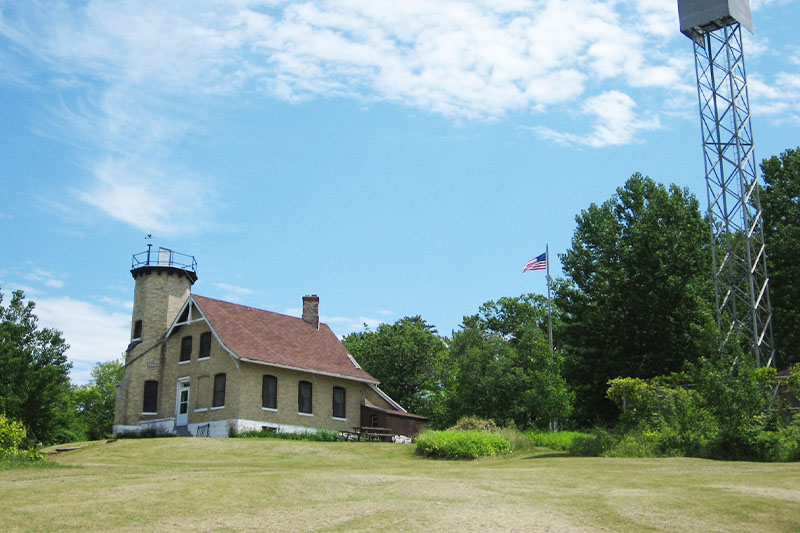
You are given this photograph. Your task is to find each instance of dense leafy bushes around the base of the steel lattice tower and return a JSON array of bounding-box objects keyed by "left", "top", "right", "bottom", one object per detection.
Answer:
[{"left": 600, "top": 352, "right": 800, "bottom": 461}]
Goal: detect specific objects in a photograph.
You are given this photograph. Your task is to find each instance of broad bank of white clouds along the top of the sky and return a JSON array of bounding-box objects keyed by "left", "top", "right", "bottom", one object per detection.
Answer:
[{"left": 0, "top": 0, "right": 688, "bottom": 121}]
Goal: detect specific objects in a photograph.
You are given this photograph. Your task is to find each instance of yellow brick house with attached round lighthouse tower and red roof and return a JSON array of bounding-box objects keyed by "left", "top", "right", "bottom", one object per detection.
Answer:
[{"left": 114, "top": 248, "right": 427, "bottom": 437}]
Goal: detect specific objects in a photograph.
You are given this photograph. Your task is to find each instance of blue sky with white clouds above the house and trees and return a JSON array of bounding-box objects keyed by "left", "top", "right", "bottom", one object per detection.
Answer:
[{"left": 0, "top": 0, "right": 800, "bottom": 383}]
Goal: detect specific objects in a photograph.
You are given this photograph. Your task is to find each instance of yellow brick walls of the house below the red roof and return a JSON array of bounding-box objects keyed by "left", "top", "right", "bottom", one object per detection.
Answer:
[{"left": 115, "top": 286, "right": 391, "bottom": 430}]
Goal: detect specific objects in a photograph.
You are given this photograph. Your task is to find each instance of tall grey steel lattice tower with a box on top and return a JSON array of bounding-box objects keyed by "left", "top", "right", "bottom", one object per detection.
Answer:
[{"left": 678, "top": 0, "right": 775, "bottom": 366}]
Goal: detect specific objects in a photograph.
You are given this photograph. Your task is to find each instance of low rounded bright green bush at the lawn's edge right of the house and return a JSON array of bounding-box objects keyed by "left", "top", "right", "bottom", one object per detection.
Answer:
[{"left": 416, "top": 430, "right": 511, "bottom": 459}]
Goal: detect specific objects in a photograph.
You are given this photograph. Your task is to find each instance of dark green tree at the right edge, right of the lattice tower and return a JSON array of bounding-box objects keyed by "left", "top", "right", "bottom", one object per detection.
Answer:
[{"left": 761, "top": 148, "right": 800, "bottom": 367}]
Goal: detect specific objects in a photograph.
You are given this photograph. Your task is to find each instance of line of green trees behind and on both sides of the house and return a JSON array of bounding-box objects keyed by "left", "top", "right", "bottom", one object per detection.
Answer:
[{"left": 0, "top": 148, "right": 800, "bottom": 444}]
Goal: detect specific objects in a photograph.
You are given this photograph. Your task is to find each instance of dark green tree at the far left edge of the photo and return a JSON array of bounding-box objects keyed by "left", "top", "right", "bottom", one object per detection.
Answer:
[{"left": 0, "top": 291, "right": 72, "bottom": 443}]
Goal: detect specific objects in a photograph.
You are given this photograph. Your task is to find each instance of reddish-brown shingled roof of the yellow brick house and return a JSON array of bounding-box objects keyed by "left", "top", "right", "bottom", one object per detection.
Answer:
[{"left": 192, "top": 294, "right": 378, "bottom": 383}]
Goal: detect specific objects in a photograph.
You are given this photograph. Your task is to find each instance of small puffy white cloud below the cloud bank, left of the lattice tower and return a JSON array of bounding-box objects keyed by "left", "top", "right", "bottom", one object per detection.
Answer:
[{"left": 533, "top": 91, "right": 660, "bottom": 148}]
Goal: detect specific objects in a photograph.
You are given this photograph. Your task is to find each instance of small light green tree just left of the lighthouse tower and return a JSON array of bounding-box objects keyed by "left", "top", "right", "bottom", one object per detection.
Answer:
[{"left": 73, "top": 360, "right": 125, "bottom": 440}]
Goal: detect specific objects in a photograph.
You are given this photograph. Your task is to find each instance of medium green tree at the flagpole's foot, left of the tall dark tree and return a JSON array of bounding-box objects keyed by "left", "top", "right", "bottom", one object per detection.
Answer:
[{"left": 447, "top": 294, "right": 572, "bottom": 427}]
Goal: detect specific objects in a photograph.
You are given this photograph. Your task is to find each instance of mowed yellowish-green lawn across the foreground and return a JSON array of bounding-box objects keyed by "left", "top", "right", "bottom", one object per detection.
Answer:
[{"left": 0, "top": 438, "right": 800, "bottom": 532}]
